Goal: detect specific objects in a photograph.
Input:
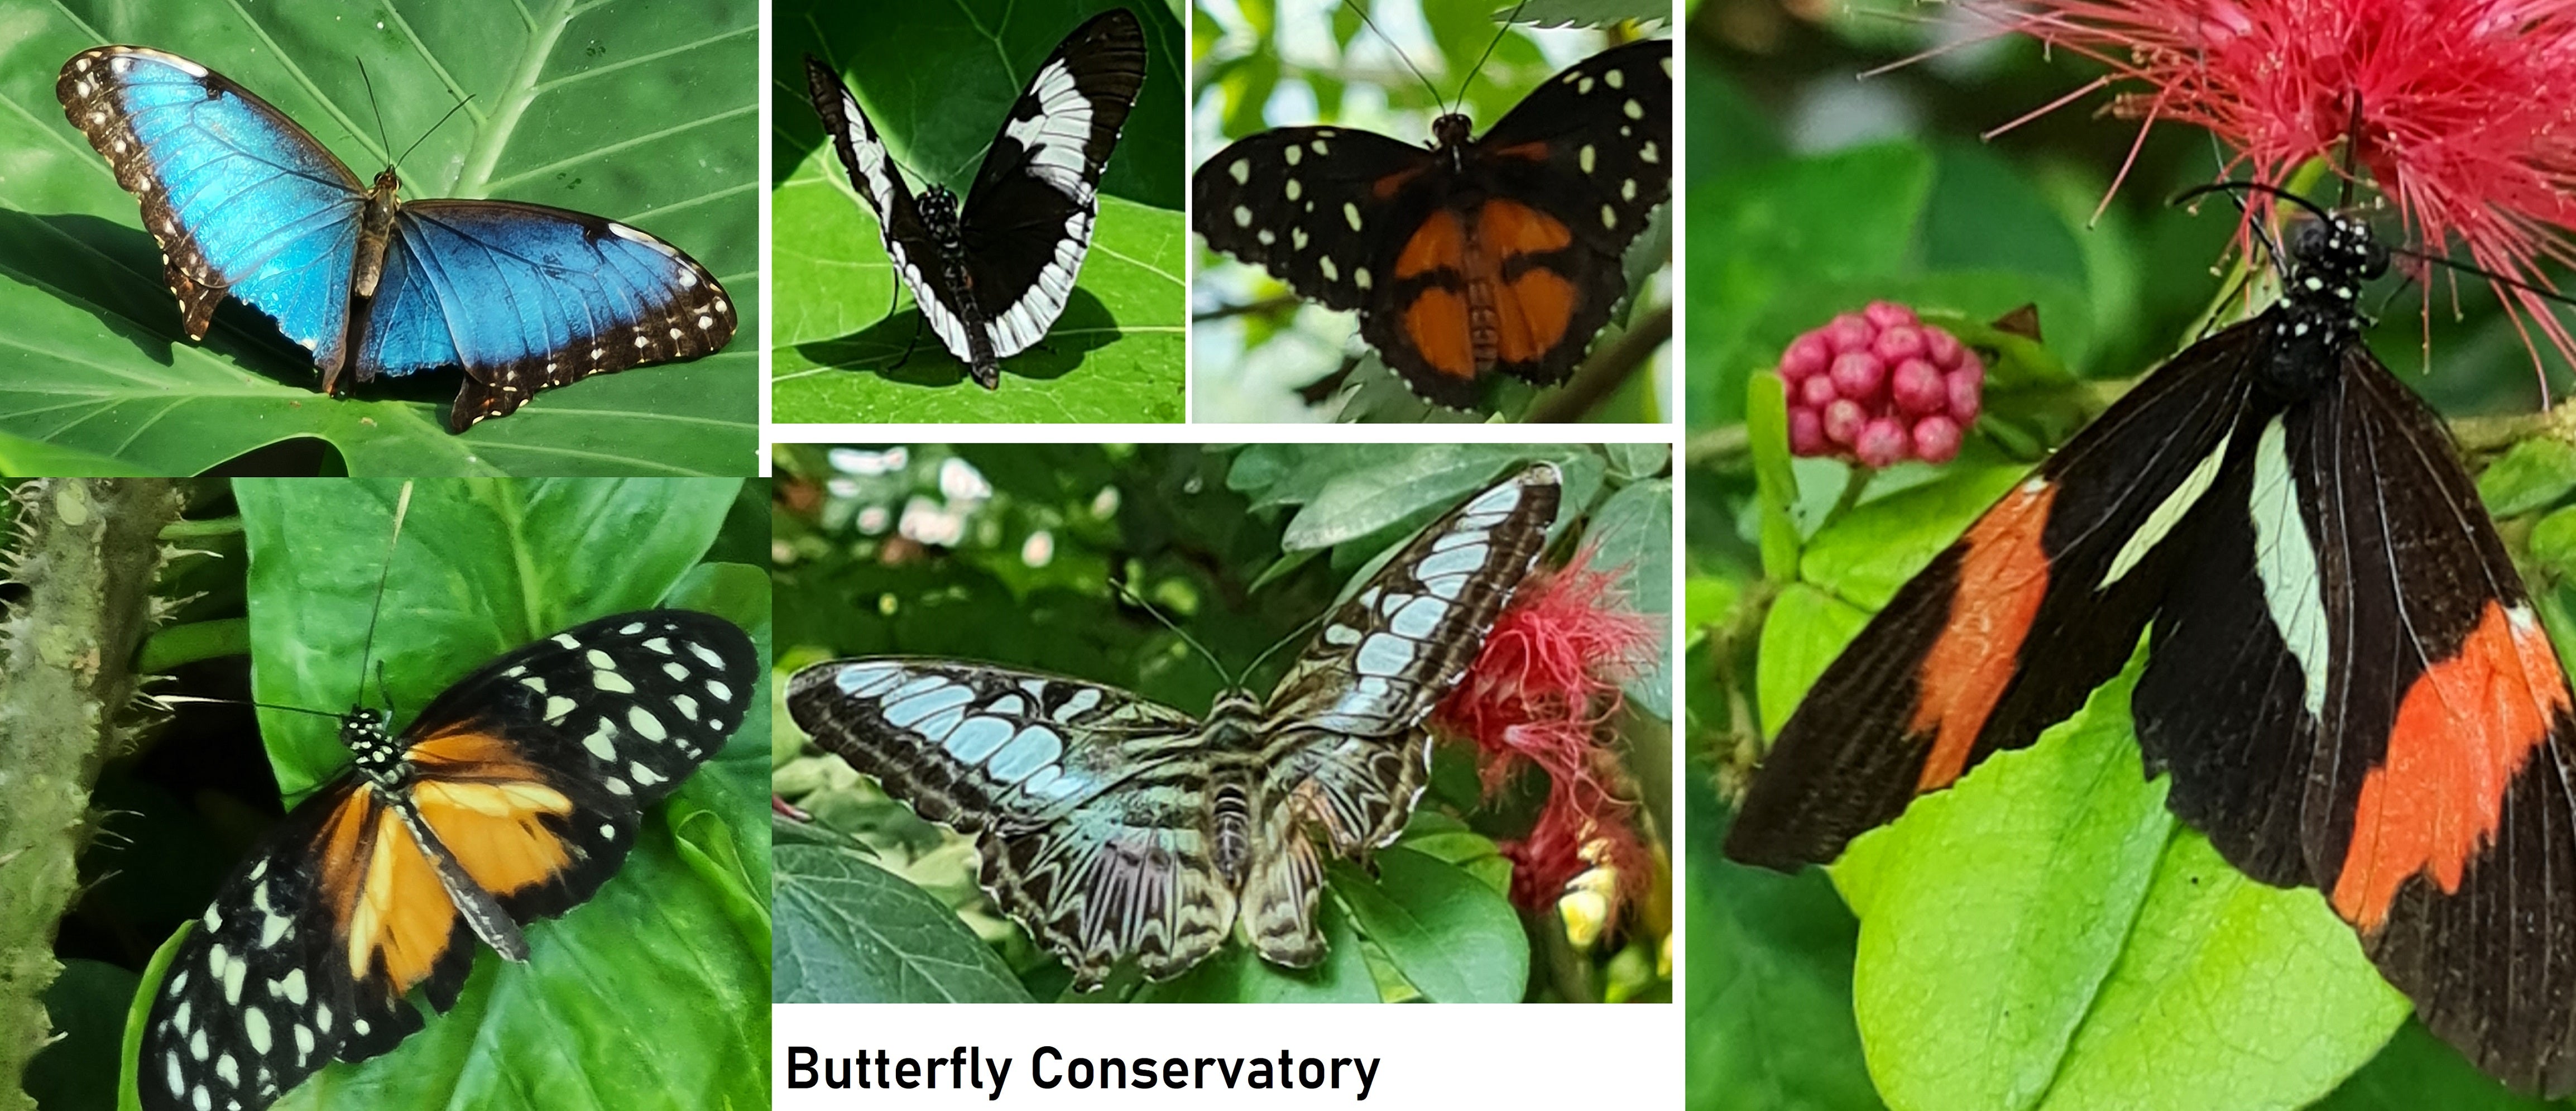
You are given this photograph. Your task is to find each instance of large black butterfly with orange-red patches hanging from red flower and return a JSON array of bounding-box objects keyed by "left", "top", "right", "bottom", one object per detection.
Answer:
[{"left": 1726, "top": 199, "right": 2576, "bottom": 1093}]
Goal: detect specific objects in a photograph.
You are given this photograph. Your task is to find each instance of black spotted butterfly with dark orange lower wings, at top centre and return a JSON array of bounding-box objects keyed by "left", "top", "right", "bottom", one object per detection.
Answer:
[{"left": 1190, "top": 39, "right": 1672, "bottom": 408}]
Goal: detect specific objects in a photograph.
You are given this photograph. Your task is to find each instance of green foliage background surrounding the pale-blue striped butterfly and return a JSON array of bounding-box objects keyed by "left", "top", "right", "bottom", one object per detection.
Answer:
[{"left": 770, "top": 443, "right": 1672, "bottom": 1003}]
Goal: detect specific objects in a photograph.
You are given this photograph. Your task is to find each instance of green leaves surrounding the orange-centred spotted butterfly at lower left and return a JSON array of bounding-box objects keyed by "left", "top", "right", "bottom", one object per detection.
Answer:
[{"left": 100, "top": 480, "right": 770, "bottom": 1108}]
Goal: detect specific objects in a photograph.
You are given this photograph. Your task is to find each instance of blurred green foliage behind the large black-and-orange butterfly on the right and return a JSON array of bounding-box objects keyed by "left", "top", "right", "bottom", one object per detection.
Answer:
[{"left": 1680, "top": 0, "right": 2576, "bottom": 1108}]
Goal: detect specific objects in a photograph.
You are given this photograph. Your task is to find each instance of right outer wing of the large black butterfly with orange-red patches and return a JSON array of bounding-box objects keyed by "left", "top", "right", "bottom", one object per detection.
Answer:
[{"left": 2287, "top": 346, "right": 2576, "bottom": 1095}]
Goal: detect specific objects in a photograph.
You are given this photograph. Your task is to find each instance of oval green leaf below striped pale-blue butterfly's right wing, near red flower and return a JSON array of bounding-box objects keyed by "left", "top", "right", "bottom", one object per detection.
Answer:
[{"left": 1329, "top": 845, "right": 1530, "bottom": 1003}]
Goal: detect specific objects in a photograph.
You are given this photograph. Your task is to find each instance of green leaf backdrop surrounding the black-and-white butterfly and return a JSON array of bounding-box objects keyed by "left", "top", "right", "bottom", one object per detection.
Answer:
[{"left": 770, "top": 0, "right": 1188, "bottom": 423}]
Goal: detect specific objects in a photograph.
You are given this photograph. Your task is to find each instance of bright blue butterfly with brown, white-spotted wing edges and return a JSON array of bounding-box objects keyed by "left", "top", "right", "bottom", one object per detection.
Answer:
[{"left": 54, "top": 46, "right": 734, "bottom": 433}]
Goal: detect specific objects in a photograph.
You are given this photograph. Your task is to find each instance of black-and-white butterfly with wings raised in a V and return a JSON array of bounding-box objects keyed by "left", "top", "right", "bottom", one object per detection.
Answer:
[{"left": 806, "top": 8, "right": 1147, "bottom": 389}]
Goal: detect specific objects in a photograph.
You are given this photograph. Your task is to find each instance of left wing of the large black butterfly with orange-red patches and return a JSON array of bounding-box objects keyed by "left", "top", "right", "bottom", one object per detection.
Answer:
[{"left": 1726, "top": 317, "right": 2270, "bottom": 869}]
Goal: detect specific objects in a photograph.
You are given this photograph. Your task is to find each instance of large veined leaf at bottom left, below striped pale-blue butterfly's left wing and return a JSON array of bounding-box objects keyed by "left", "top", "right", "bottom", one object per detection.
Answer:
[{"left": 770, "top": 832, "right": 1030, "bottom": 1003}]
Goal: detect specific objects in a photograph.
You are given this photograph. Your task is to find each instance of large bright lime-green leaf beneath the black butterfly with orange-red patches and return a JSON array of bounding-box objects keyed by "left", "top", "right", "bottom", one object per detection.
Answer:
[{"left": 1834, "top": 660, "right": 2406, "bottom": 1108}]
